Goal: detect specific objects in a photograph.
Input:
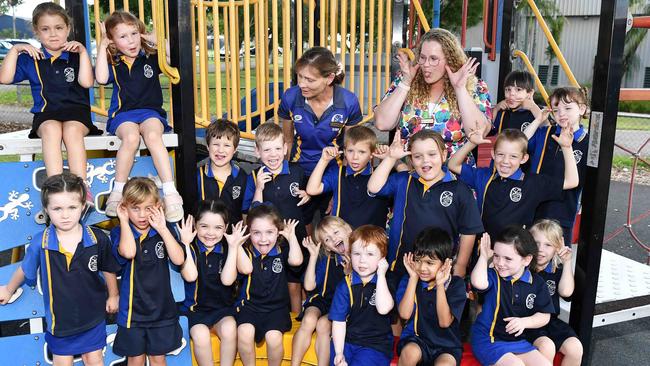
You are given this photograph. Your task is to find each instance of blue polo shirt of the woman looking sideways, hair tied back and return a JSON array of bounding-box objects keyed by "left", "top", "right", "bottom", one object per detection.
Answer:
[{"left": 278, "top": 85, "right": 363, "bottom": 176}]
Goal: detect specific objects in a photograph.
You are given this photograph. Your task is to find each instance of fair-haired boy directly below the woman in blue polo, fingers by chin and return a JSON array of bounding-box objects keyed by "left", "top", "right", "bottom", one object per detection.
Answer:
[{"left": 242, "top": 122, "right": 310, "bottom": 313}]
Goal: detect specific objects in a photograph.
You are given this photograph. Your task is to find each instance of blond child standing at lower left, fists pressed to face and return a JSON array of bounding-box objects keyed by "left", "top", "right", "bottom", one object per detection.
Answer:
[{"left": 111, "top": 177, "right": 191, "bottom": 365}]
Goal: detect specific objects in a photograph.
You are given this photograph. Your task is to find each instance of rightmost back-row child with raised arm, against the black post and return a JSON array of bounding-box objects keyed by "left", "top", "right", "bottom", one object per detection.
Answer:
[{"left": 524, "top": 87, "right": 589, "bottom": 245}]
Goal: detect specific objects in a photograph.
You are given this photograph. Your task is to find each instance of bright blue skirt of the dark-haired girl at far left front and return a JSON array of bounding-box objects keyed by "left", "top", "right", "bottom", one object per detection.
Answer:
[{"left": 45, "top": 321, "right": 106, "bottom": 356}]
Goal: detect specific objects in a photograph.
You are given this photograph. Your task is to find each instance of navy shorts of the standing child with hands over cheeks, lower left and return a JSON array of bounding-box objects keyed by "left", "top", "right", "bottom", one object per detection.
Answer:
[{"left": 113, "top": 322, "right": 183, "bottom": 357}]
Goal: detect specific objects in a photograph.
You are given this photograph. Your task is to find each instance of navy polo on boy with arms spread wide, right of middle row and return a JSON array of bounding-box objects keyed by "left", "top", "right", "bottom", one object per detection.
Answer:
[{"left": 460, "top": 164, "right": 564, "bottom": 237}]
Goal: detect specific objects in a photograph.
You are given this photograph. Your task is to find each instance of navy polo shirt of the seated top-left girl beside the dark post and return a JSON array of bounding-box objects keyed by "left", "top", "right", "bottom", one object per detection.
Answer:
[{"left": 99, "top": 51, "right": 167, "bottom": 119}]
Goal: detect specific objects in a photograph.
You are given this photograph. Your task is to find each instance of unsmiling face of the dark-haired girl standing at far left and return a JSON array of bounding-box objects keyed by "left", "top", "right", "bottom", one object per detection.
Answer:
[{"left": 45, "top": 192, "right": 84, "bottom": 231}]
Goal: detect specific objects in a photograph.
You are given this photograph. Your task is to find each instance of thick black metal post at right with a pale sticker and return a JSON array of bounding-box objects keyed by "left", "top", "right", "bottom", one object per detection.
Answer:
[{"left": 570, "top": 0, "right": 628, "bottom": 364}]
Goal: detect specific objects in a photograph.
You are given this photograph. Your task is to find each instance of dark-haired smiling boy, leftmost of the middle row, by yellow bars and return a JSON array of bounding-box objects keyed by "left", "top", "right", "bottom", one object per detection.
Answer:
[{"left": 196, "top": 119, "right": 248, "bottom": 224}]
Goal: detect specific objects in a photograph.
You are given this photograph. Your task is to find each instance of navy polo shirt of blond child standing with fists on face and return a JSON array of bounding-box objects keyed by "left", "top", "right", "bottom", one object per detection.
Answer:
[{"left": 111, "top": 224, "right": 178, "bottom": 328}]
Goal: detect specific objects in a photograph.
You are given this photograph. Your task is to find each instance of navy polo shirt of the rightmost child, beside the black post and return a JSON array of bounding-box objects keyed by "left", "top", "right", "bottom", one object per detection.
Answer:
[{"left": 528, "top": 126, "right": 589, "bottom": 227}]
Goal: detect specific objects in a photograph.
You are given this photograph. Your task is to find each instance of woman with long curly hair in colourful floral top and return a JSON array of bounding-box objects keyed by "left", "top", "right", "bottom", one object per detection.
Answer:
[{"left": 375, "top": 28, "right": 492, "bottom": 164}]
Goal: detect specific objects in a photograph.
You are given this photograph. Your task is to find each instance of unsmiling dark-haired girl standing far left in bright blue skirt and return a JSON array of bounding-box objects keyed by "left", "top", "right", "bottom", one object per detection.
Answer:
[{"left": 0, "top": 172, "right": 120, "bottom": 365}]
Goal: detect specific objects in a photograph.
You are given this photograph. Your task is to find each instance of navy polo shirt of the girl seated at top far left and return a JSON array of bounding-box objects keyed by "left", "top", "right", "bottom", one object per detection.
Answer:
[{"left": 12, "top": 48, "right": 90, "bottom": 113}]
